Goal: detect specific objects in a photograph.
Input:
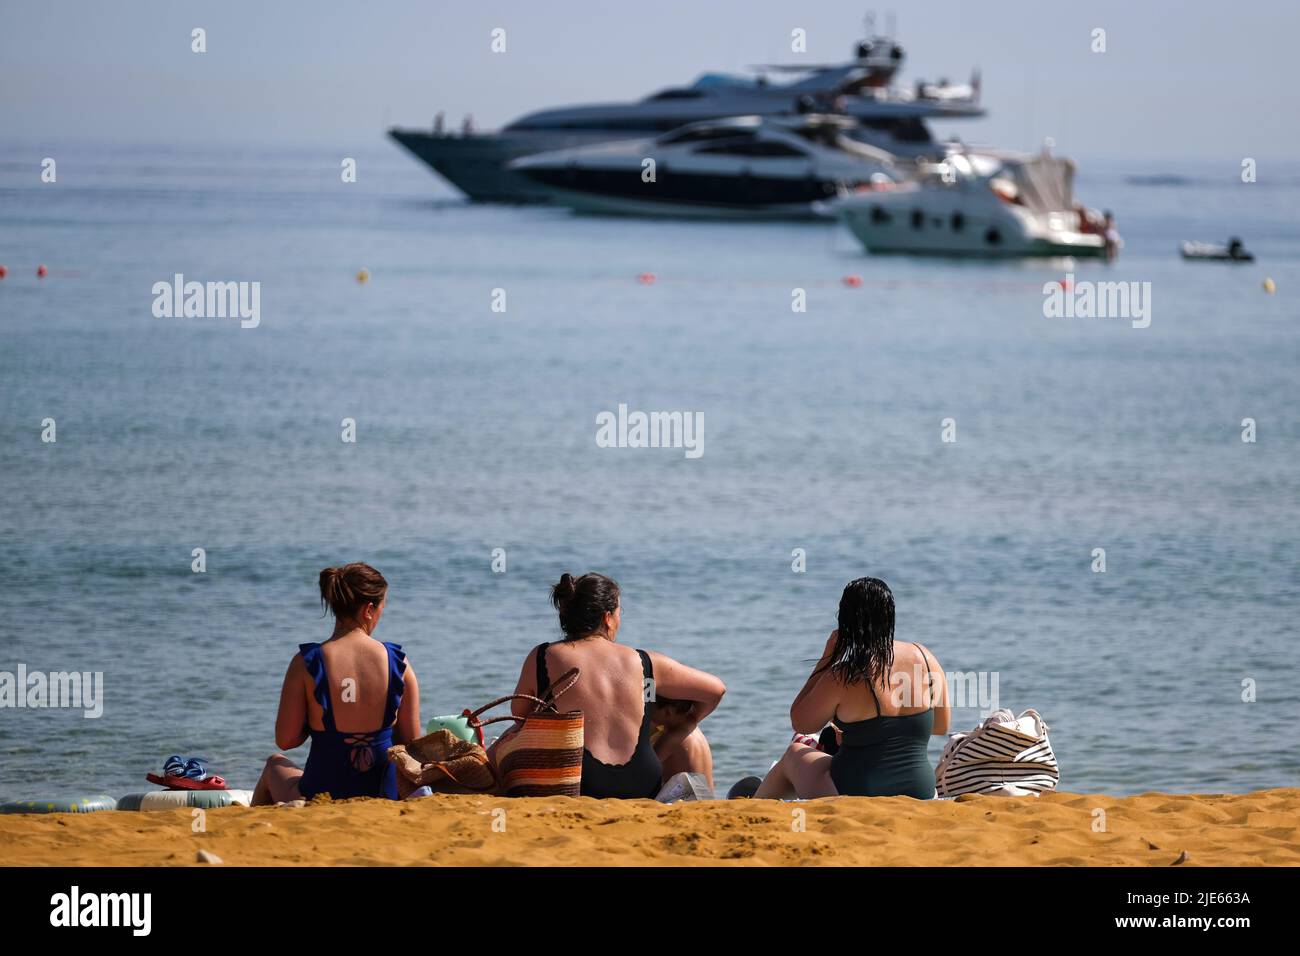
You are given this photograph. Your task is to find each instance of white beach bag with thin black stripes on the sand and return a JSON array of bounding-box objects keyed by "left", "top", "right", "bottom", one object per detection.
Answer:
[{"left": 935, "top": 710, "right": 1061, "bottom": 797}]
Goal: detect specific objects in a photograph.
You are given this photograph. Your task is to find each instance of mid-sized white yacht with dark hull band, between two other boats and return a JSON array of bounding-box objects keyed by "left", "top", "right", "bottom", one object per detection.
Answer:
[{"left": 510, "top": 113, "right": 901, "bottom": 219}]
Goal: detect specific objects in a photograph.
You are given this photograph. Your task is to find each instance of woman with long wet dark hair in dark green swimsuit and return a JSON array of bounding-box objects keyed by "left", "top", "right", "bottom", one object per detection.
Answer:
[{"left": 754, "top": 578, "right": 952, "bottom": 800}]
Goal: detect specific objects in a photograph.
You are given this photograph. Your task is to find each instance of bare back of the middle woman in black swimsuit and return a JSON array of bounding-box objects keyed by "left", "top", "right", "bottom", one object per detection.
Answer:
[{"left": 538, "top": 639, "right": 645, "bottom": 763}]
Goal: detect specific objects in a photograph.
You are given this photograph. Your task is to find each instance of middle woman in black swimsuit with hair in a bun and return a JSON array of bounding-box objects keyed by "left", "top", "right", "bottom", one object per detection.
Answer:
[{"left": 512, "top": 572, "right": 727, "bottom": 799}]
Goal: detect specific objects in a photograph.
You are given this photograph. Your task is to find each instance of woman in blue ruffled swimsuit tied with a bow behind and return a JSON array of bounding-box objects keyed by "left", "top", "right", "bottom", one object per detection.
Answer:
[{"left": 252, "top": 562, "right": 420, "bottom": 805}]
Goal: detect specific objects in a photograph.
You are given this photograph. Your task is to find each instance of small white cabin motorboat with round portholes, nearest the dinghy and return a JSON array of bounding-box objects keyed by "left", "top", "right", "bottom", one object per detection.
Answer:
[{"left": 826, "top": 150, "right": 1121, "bottom": 258}]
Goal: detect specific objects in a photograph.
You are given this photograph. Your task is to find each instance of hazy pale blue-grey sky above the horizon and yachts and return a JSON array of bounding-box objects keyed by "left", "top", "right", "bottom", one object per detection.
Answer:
[{"left": 0, "top": 0, "right": 1300, "bottom": 165}]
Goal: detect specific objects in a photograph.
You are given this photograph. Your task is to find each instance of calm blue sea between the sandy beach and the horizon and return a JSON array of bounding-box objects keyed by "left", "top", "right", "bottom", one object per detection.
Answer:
[{"left": 0, "top": 139, "right": 1300, "bottom": 799}]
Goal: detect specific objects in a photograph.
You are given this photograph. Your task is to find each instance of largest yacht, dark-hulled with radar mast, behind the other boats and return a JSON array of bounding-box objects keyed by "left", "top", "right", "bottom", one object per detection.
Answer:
[{"left": 389, "top": 27, "right": 984, "bottom": 202}]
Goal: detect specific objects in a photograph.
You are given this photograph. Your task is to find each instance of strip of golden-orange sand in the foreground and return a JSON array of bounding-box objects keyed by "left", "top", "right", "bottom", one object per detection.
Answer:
[{"left": 0, "top": 790, "right": 1300, "bottom": 866}]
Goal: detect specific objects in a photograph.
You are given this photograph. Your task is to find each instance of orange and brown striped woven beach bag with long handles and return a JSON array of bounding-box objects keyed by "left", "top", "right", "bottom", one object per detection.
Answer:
[{"left": 465, "top": 667, "right": 585, "bottom": 796}]
